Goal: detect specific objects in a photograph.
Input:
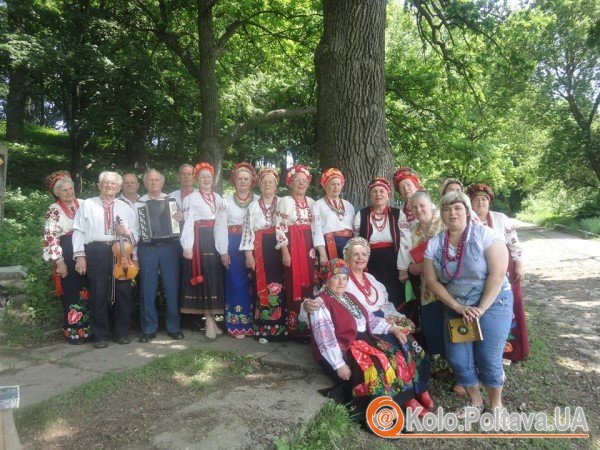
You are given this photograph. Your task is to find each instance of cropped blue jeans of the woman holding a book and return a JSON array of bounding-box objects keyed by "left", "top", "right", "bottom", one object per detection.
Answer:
[{"left": 444, "top": 288, "right": 513, "bottom": 388}]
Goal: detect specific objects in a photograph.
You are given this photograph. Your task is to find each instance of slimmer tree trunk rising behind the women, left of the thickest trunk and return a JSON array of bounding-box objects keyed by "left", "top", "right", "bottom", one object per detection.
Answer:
[{"left": 197, "top": 0, "right": 225, "bottom": 181}]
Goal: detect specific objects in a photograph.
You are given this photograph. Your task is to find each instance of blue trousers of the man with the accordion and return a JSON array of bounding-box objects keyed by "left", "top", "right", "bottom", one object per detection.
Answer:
[{"left": 138, "top": 242, "right": 181, "bottom": 334}]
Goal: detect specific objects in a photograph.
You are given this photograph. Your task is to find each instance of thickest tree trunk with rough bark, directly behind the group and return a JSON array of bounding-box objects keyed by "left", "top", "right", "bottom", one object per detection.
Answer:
[{"left": 315, "top": 0, "right": 394, "bottom": 206}]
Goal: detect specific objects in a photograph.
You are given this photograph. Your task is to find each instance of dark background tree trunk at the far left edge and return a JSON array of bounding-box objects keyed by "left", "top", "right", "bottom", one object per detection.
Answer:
[{"left": 6, "top": 67, "right": 27, "bottom": 142}]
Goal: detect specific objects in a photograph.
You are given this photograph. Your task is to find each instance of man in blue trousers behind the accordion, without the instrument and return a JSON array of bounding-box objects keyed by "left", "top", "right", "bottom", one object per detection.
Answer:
[{"left": 134, "top": 169, "right": 184, "bottom": 343}]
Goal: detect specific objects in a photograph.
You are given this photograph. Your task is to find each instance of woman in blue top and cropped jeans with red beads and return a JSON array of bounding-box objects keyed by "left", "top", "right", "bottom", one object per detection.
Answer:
[{"left": 423, "top": 192, "right": 513, "bottom": 417}]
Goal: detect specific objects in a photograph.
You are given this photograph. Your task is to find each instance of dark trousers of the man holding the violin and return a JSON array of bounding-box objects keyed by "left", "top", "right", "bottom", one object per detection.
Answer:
[{"left": 85, "top": 243, "right": 131, "bottom": 341}]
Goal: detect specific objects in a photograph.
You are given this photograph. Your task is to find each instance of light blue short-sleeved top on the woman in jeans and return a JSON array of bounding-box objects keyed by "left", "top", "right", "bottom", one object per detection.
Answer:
[{"left": 433, "top": 224, "right": 510, "bottom": 306}]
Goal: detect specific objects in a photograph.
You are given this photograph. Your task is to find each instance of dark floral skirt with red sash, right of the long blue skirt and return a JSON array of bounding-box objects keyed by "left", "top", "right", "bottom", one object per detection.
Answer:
[{"left": 253, "top": 227, "right": 288, "bottom": 341}]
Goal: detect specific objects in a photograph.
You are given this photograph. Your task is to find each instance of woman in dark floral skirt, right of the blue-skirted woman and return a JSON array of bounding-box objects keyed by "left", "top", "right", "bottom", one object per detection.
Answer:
[{"left": 240, "top": 167, "right": 288, "bottom": 344}]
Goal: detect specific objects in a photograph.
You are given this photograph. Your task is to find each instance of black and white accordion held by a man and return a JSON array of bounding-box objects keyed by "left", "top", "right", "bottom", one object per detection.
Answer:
[{"left": 138, "top": 197, "right": 181, "bottom": 243}]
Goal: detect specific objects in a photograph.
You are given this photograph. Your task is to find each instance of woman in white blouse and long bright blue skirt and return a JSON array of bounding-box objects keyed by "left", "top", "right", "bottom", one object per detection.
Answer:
[{"left": 215, "top": 163, "right": 258, "bottom": 339}]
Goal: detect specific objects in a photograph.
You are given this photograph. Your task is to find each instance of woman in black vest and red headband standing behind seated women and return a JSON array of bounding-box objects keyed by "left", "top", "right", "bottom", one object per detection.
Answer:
[{"left": 354, "top": 178, "right": 413, "bottom": 312}]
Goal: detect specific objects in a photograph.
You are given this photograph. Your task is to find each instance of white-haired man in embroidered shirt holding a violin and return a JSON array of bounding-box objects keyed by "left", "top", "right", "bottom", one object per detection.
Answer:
[{"left": 73, "top": 171, "right": 139, "bottom": 348}]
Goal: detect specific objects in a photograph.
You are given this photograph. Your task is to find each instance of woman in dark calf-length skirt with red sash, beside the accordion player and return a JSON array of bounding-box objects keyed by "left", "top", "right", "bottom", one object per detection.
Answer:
[{"left": 180, "top": 162, "right": 225, "bottom": 339}]
